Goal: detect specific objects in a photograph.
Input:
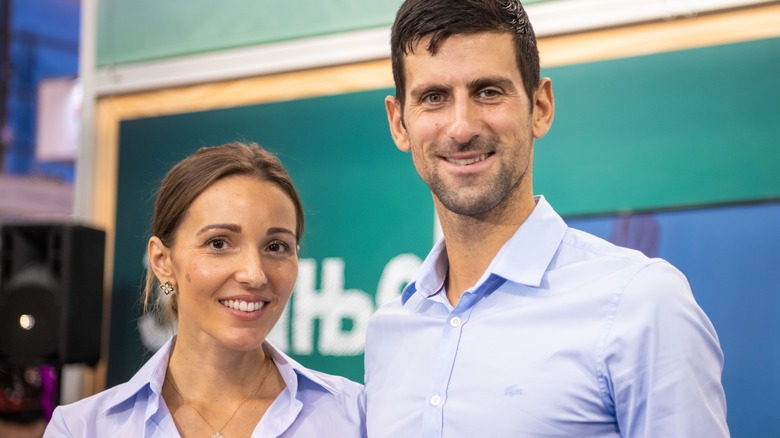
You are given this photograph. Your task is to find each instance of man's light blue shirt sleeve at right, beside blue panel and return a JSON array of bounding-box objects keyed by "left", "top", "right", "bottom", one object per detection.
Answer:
[{"left": 602, "top": 260, "right": 729, "bottom": 438}]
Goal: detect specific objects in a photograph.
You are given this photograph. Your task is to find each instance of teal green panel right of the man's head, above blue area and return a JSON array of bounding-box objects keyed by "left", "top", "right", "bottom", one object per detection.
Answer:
[{"left": 534, "top": 38, "right": 780, "bottom": 215}]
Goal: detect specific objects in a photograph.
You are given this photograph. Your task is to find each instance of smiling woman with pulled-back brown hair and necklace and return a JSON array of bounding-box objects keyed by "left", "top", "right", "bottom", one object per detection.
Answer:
[{"left": 45, "top": 143, "right": 365, "bottom": 438}]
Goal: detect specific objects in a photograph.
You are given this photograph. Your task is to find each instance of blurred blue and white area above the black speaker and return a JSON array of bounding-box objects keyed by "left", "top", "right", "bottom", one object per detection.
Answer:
[{"left": 0, "top": 0, "right": 81, "bottom": 221}]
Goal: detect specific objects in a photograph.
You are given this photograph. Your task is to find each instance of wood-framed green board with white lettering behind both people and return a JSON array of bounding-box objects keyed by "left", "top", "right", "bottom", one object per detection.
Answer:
[{"left": 108, "top": 39, "right": 780, "bottom": 386}]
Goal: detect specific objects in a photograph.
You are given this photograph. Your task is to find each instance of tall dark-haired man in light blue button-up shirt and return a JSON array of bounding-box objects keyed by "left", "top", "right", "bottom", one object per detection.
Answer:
[{"left": 366, "top": 0, "right": 729, "bottom": 438}]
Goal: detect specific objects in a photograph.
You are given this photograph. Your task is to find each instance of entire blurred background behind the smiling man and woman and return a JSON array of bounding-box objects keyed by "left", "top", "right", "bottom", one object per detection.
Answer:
[{"left": 0, "top": 0, "right": 780, "bottom": 437}]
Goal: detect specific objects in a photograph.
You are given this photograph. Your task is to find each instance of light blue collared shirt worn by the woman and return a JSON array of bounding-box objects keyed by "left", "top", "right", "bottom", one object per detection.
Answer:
[{"left": 44, "top": 338, "right": 365, "bottom": 438}]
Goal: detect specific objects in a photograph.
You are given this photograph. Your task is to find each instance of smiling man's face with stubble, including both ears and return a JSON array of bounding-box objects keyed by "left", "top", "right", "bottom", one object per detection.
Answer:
[{"left": 386, "top": 32, "right": 552, "bottom": 216}]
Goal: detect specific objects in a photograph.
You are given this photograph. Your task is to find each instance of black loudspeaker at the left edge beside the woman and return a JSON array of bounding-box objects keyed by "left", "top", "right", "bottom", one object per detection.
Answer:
[{"left": 0, "top": 223, "right": 106, "bottom": 365}]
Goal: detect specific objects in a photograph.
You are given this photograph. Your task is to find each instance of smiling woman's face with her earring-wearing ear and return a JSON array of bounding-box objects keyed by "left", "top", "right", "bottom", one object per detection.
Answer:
[{"left": 151, "top": 176, "right": 298, "bottom": 350}]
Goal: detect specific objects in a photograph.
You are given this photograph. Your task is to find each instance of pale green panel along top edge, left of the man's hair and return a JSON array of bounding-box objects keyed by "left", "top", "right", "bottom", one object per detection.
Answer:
[{"left": 96, "top": 0, "right": 549, "bottom": 67}]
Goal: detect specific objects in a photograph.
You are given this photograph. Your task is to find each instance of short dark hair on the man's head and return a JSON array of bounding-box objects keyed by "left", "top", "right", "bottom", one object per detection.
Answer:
[{"left": 390, "top": 0, "right": 539, "bottom": 108}]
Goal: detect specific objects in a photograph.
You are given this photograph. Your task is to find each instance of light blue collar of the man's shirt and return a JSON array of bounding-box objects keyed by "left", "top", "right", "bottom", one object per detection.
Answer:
[{"left": 401, "top": 196, "right": 567, "bottom": 304}]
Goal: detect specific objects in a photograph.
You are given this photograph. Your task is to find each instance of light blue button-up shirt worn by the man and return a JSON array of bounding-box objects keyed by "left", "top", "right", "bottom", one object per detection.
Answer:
[{"left": 365, "top": 197, "right": 729, "bottom": 438}]
